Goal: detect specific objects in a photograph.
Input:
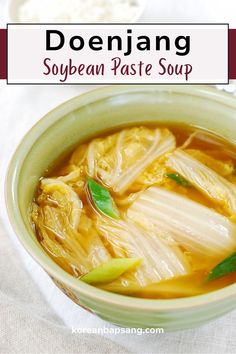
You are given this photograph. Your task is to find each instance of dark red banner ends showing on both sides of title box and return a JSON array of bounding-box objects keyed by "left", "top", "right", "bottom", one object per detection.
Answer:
[{"left": 0, "top": 29, "right": 236, "bottom": 80}]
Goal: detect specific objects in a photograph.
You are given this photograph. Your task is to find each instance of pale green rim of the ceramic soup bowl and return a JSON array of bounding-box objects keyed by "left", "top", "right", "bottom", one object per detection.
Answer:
[{"left": 5, "top": 85, "right": 236, "bottom": 312}]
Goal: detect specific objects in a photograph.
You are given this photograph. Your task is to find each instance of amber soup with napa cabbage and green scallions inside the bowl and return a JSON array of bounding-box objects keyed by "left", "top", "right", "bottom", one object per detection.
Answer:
[{"left": 32, "top": 125, "right": 236, "bottom": 298}]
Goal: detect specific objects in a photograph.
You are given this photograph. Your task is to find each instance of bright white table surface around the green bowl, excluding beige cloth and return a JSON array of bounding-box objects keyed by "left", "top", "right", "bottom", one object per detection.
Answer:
[{"left": 0, "top": 0, "right": 236, "bottom": 353}]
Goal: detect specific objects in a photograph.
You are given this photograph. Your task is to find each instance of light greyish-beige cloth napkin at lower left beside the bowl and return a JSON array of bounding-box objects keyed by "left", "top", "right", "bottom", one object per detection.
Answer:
[{"left": 0, "top": 223, "right": 128, "bottom": 354}]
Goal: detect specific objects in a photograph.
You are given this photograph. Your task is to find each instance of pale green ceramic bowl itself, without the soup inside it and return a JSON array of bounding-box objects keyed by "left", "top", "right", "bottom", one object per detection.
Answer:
[{"left": 6, "top": 86, "right": 236, "bottom": 331}]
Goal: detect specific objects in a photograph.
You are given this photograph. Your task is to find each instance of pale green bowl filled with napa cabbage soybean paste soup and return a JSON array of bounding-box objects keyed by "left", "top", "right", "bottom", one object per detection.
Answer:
[{"left": 6, "top": 85, "right": 236, "bottom": 331}]
